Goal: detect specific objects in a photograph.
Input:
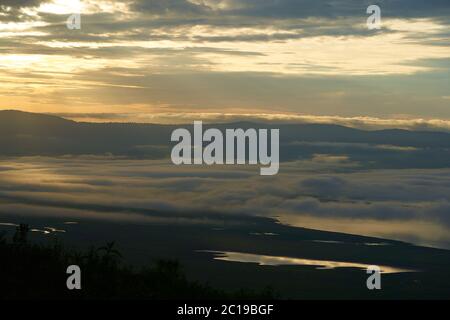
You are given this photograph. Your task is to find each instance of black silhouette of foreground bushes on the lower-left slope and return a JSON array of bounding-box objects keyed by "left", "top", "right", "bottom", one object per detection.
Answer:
[{"left": 0, "top": 224, "right": 274, "bottom": 299}]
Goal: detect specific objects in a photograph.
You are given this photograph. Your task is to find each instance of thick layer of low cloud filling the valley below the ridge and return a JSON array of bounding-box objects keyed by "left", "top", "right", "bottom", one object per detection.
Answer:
[{"left": 0, "top": 156, "right": 450, "bottom": 247}]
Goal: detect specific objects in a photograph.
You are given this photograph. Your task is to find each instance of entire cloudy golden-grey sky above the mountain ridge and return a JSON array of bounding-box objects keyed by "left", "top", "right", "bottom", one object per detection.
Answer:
[{"left": 0, "top": 0, "right": 450, "bottom": 129}]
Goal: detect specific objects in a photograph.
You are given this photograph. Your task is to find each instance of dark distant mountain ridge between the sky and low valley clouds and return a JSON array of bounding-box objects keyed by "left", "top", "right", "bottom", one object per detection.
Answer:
[{"left": 0, "top": 110, "right": 450, "bottom": 167}]
